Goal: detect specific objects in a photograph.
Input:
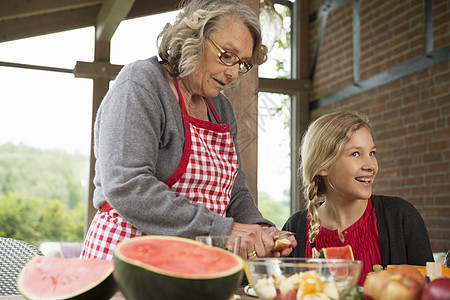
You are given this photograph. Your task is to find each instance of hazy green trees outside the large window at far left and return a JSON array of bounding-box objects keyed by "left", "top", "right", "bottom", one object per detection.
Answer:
[{"left": 0, "top": 143, "right": 89, "bottom": 245}]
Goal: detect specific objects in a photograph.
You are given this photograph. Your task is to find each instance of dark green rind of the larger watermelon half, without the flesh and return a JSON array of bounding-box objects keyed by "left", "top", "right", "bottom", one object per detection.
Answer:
[{"left": 113, "top": 236, "right": 245, "bottom": 300}]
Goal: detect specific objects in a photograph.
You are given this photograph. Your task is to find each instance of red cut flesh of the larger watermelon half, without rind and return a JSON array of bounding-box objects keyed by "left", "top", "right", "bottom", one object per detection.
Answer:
[{"left": 121, "top": 238, "right": 237, "bottom": 278}]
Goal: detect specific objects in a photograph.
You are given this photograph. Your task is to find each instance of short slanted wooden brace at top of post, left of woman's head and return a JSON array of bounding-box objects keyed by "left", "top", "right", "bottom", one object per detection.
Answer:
[{"left": 95, "top": 0, "right": 134, "bottom": 42}]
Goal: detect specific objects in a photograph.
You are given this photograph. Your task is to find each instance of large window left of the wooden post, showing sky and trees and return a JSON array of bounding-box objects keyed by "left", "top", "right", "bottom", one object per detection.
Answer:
[{"left": 0, "top": 28, "right": 94, "bottom": 250}]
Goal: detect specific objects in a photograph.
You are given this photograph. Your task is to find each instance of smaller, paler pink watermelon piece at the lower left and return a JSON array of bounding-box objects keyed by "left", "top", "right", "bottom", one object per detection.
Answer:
[{"left": 17, "top": 256, "right": 117, "bottom": 300}]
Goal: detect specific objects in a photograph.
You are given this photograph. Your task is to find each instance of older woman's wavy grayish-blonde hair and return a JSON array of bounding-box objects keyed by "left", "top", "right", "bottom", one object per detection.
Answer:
[{"left": 158, "top": 0, "right": 267, "bottom": 78}]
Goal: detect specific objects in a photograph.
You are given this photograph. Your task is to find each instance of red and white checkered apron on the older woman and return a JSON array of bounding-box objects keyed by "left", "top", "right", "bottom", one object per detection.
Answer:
[{"left": 81, "top": 80, "right": 239, "bottom": 259}]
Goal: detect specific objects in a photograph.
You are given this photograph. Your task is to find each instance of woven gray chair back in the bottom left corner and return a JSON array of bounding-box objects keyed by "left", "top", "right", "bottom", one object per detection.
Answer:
[{"left": 0, "top": 237, "right": 43, "bottom": 296}]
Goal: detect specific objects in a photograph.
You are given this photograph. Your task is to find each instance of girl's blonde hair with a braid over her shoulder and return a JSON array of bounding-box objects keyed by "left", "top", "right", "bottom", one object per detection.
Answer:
[{"left": 300, "top": 111, "right": 373, "bottom": 244}]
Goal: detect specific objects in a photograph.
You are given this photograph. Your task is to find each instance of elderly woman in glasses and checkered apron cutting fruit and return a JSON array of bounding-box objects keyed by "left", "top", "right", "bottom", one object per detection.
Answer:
[{"left": 81, "top": 0, "right": 296, "bottom": 259}]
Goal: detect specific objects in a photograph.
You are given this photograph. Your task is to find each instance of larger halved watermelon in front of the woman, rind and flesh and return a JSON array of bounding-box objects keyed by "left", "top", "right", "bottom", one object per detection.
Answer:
[{"left": 114, "top": 236, "right": 244, "bottom": 300}]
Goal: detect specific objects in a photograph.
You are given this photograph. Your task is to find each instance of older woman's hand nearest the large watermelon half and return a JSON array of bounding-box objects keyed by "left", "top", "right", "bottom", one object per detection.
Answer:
[{"left": 229, "top": 222, "right": 274, "bottom": 259}]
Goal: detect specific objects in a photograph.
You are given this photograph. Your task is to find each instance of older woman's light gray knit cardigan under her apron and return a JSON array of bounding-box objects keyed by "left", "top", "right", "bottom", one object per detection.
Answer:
[{"left": 94, "top": 57, "right": 273, "bottom": 238}]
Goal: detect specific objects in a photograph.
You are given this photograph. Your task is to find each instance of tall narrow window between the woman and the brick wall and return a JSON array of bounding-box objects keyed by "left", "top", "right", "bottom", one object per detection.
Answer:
[{"left": 258, "top": 4, "right": 292, "bottom": 228}]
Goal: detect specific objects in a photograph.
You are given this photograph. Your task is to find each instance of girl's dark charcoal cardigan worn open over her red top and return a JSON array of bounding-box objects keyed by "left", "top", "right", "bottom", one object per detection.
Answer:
[{"left": 283, "top": 195, "right": 434, "bottom": 267}]
